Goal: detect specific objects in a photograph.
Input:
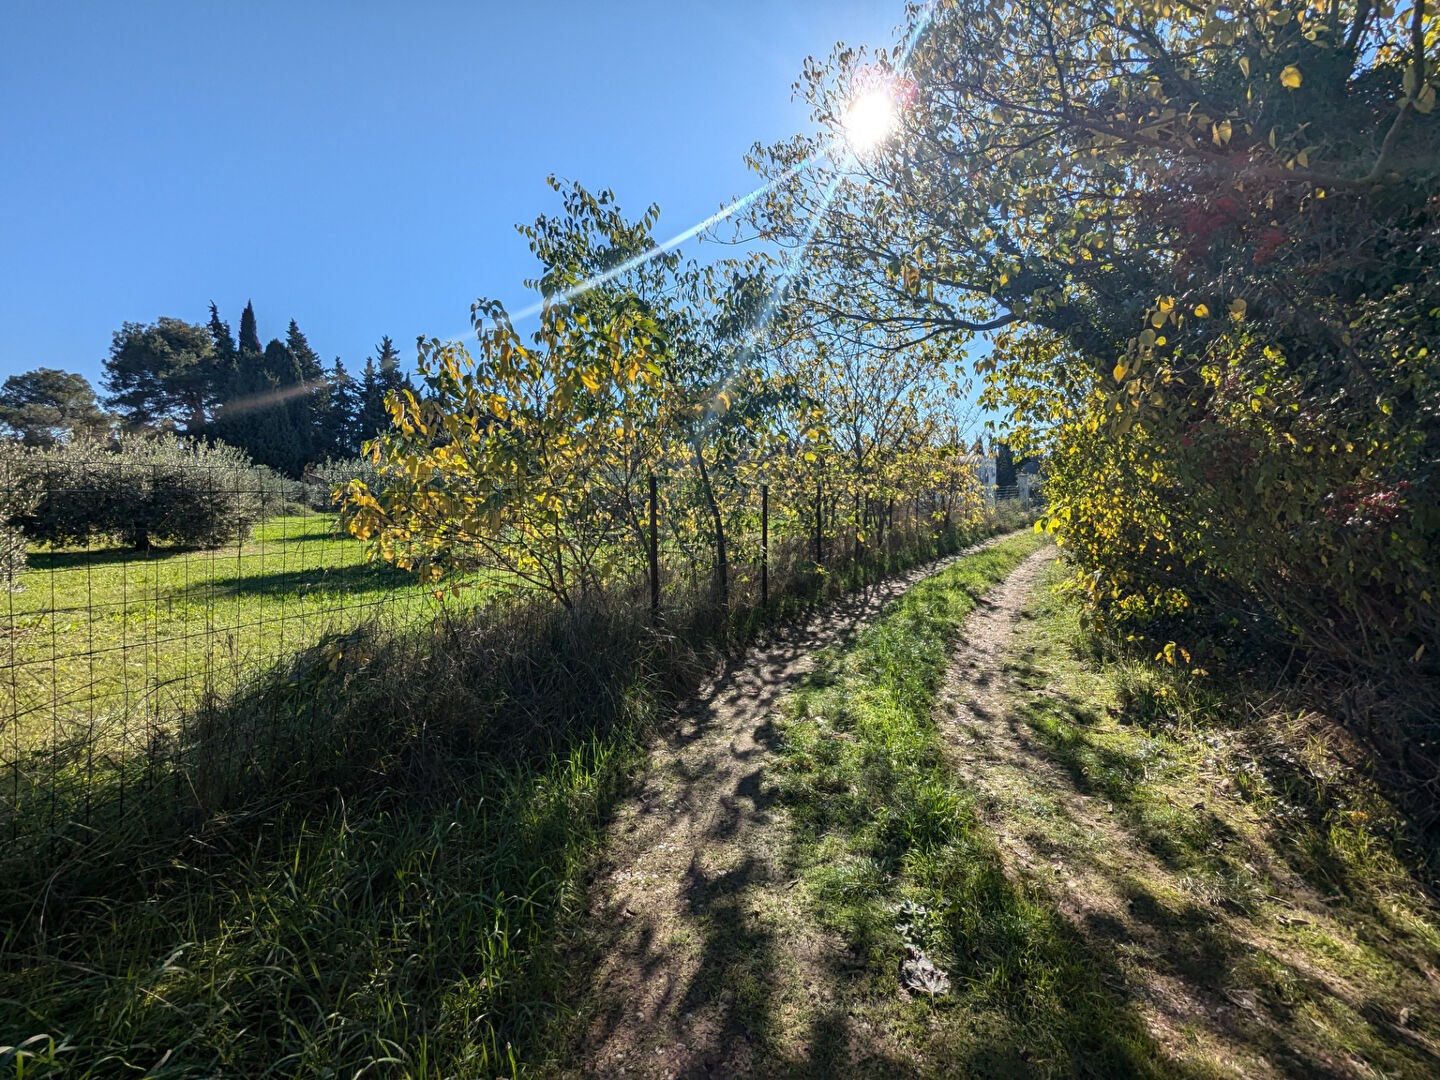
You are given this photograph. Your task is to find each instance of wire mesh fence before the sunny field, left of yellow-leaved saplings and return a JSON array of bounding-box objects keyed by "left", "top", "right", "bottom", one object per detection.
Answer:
[{"left": 0, "top": 458, "right": 464, "bottom": 858}]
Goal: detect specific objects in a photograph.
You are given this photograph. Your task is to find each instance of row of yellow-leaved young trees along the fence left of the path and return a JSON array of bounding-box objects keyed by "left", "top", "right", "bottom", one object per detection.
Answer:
[{"left": 346, "top": 184, "right": 978, "bottom": 608}]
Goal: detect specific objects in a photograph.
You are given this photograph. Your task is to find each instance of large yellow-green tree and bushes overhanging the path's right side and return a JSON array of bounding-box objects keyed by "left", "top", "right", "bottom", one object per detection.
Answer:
[{"left": 759, "top": 0, "right": 1440, "bottom": 683}]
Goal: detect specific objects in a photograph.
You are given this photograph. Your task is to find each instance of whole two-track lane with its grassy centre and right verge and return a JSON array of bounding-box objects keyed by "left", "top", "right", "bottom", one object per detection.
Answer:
[{"left": 559, "top": 537, "right": 1440, "bottom": 1077}]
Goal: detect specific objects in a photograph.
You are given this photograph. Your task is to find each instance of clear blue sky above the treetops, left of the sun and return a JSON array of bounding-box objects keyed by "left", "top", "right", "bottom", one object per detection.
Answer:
[{"left": 0, "top": 0, "right": 903, "bottom": 389}]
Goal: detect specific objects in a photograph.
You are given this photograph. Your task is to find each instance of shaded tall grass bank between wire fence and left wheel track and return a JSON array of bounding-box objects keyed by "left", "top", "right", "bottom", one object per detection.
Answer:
[{"left": 0, "top": 512, "right": 1036, "bottom": 1080}]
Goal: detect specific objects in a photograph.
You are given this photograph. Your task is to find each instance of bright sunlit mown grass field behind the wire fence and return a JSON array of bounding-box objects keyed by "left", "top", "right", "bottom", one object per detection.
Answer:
[{"left": 0, "top": 514, "right": 474, "bottom": 746}]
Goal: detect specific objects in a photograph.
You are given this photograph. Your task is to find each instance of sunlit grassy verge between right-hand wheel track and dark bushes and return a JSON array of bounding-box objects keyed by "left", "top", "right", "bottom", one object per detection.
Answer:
[{"left": 1015, "top": 567, "right": 1440, "bottom": 1077}]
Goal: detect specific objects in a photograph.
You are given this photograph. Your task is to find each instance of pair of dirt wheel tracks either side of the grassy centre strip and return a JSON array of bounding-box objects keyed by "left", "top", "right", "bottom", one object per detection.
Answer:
[{"left": 566, "top": 547, "right": 1440, "bottom": 1077}]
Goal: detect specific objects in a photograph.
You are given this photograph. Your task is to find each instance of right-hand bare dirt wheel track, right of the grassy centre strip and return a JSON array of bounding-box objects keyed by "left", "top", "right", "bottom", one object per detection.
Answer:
[{"left": 937, "top": 549, "right": 1434, "bottom": 1077}]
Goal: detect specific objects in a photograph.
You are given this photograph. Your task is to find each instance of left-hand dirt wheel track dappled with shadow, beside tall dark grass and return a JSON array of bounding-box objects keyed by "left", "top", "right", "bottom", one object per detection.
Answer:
[{"left": 575, "top": 537, "right": 999, "bottom": 1077}]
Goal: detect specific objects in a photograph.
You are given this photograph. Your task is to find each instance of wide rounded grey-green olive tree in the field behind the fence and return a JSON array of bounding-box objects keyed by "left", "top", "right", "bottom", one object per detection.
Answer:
[{"left": 12, "top": 435, "right": 289, "bottom": 550}]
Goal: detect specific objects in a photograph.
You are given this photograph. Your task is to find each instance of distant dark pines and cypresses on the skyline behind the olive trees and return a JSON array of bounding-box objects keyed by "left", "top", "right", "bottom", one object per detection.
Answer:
[{"left": 0, "top": 304, "right": 410, "bottom": 477}]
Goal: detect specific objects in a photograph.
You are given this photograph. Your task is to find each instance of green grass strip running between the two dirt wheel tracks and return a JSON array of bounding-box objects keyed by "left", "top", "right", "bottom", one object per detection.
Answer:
[{"left": 783, "top": 536, "right": 1176, "bottom": 1076}]
